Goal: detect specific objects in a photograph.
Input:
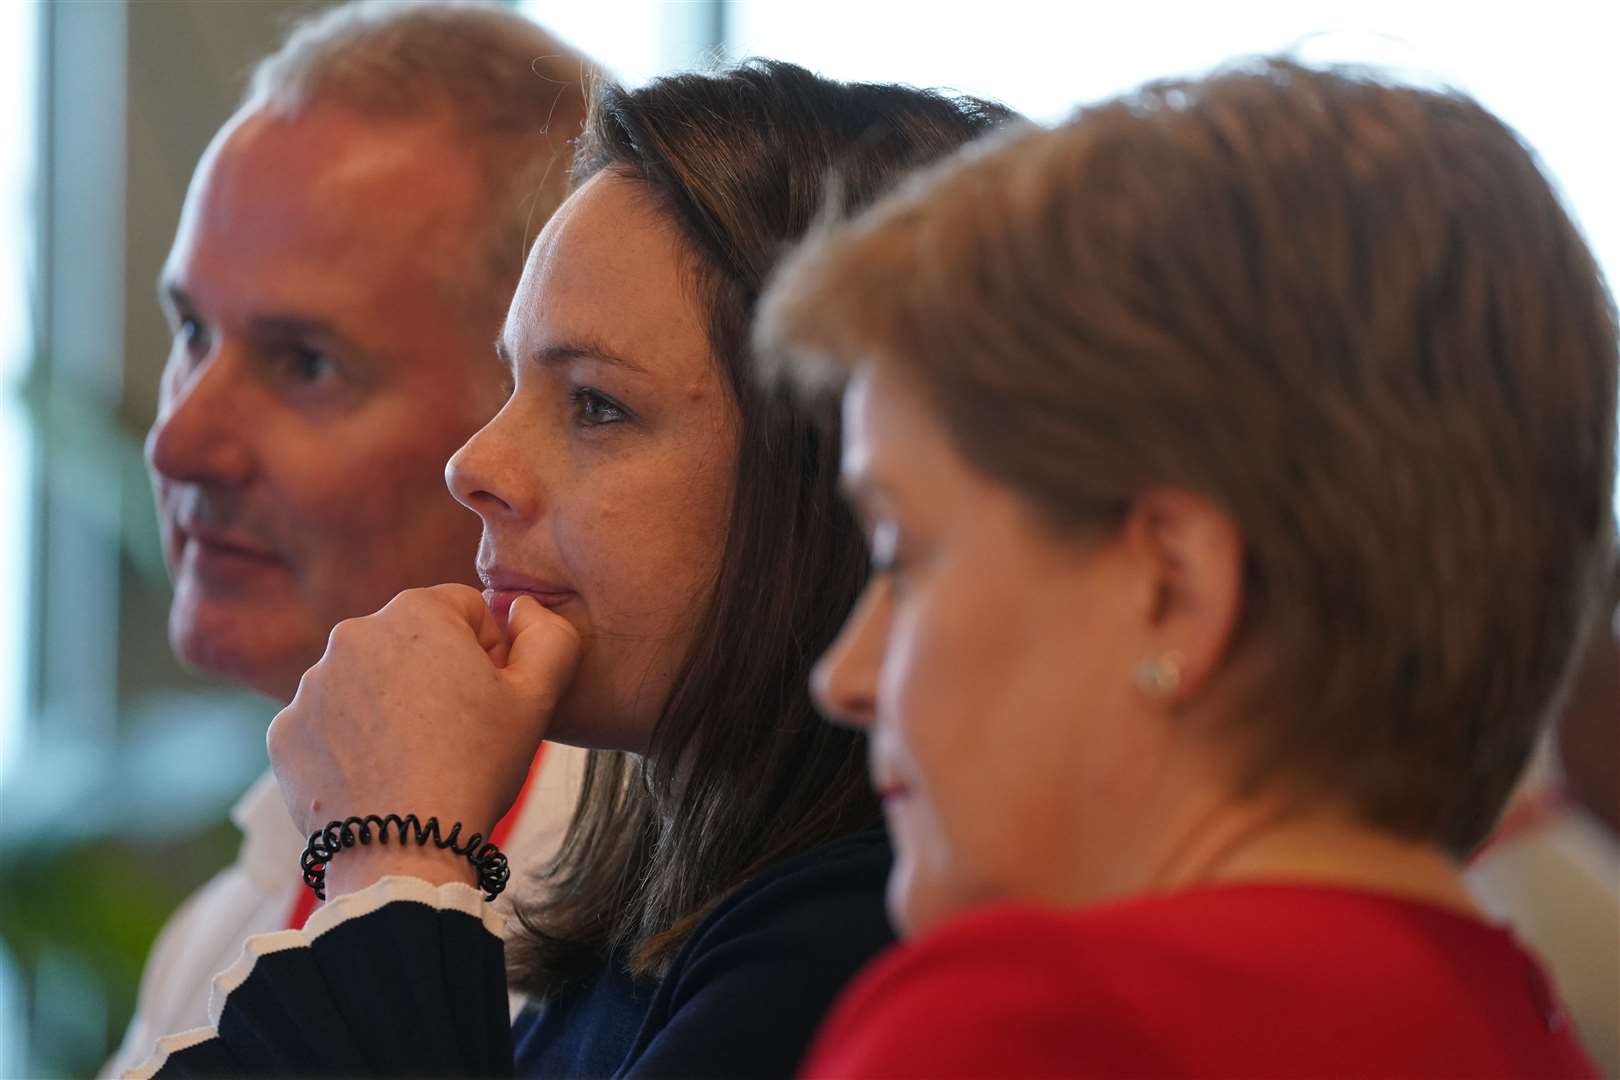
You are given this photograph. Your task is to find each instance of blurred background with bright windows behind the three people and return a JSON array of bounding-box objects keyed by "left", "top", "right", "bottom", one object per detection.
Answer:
[{"left": 0, "top": 0, "right": 1620, "bottom": 1077}]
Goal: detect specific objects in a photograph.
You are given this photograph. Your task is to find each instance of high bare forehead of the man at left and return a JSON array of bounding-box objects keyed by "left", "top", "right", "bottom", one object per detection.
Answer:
[{"left": 164, "top": 105, "right": 481, "bottom": 331}]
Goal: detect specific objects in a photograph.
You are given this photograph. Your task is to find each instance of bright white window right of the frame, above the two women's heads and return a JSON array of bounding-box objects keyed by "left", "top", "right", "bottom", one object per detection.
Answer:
[{"left": 726, "top": 0, "right": 1620, "bottom": 524}]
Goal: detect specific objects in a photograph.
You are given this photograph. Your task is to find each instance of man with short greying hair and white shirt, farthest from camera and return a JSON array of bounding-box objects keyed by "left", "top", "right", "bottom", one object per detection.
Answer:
[{"left": 105, "top": 0, "right": 590, "bottom": 1074}]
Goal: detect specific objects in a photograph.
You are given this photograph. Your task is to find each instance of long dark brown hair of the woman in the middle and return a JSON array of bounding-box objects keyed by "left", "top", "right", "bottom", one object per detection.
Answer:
[{"left": 510, "top": 62, "right": 1009, "bottom": 996}]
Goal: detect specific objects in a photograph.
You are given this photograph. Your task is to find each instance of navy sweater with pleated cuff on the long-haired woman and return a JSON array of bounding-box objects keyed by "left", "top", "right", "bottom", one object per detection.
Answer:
[{"left": 157, "top": 829, "right": 893, "bottom": 1078}]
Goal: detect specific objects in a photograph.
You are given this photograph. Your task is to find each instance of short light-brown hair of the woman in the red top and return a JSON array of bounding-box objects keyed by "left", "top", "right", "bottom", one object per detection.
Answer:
[{"left": 757, "top": 60, "right": 1617, "bottom": 852}]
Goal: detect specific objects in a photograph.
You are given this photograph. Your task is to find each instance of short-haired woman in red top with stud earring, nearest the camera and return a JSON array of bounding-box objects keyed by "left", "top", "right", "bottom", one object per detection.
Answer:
[{"left": 760, "top": 62, "right": 1617, "bottom": 1077}]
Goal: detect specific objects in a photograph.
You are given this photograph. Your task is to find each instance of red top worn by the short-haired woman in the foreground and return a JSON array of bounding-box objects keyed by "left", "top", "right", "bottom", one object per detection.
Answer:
[{"left": 804, "top": 884, "right": 1597, "bottom": 1080}]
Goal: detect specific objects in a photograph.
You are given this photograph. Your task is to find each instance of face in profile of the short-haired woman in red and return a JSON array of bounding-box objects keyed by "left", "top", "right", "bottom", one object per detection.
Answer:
[{"left": 813, "top": 364, "right": 1160, "bottom": 934}]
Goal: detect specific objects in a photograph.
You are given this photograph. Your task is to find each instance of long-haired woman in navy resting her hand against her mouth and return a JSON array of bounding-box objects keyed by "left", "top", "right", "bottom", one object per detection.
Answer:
[{"left": 129, "top": 62, "right": 1008, "bottom": 1075}]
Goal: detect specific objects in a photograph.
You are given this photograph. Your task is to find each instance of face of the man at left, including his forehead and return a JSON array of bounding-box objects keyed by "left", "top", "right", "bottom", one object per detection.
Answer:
[{"left": 146, "top": 105, "right": 509, "bottom": 701}]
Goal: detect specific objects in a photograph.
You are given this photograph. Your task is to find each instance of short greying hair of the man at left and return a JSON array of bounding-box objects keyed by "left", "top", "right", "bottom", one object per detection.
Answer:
[{"left": 243, "top": 0, "right": 596, "bottom": 304}]
